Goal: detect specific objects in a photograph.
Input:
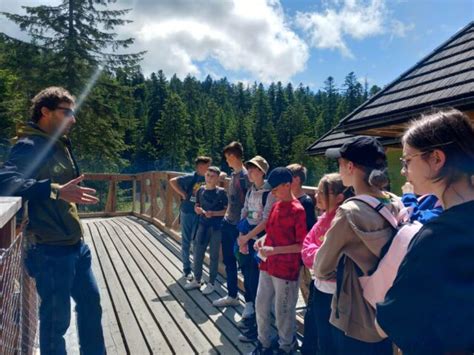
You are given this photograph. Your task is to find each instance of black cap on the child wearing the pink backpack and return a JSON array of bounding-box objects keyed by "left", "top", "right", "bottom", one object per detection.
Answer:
[{"left": 326, "top": 136, "right": 387, "bottom": 169}]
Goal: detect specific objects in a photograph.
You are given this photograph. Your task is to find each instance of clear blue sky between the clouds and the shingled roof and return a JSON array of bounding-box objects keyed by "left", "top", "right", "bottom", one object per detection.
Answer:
[{"left": 282, "top": 0, "right": 474, "bottom": 88}]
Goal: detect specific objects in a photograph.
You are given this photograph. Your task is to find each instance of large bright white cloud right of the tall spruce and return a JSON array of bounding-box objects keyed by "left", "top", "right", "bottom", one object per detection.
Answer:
[{"left": 118, "top": 0, "right": 309, "bottom": 82}]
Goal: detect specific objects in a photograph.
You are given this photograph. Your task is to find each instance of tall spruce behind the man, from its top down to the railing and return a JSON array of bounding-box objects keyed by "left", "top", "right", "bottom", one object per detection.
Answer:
[{"left": 2, "top": 0, "right": 143, "bottom": 171}]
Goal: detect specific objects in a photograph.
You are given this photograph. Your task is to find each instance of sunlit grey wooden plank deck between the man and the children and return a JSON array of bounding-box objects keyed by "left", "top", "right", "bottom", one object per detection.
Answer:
[{"left": 67, "top": 217, "right": 266, "bottom": 355}]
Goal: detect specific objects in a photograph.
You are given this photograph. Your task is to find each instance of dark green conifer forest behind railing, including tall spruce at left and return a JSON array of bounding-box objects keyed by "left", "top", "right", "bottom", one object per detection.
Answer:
[{"left": 0, "top": 0, "right": 380, "bottom": 183}]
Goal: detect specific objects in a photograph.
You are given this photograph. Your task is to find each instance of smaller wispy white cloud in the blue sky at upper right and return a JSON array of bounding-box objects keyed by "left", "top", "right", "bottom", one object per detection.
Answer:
[{"left": 295, "top": 0, "right": 413, "bottom": 58}]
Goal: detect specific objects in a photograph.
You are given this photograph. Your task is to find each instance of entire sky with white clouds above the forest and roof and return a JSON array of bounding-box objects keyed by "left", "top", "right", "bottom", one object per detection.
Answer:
[{"left": 0, "top": 0, "right": 474, "bottom": 90}]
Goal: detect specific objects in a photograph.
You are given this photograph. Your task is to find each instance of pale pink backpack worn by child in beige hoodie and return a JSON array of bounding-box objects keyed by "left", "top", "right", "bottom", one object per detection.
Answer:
[{"left": 351, "top": 195, "right": 423, "bottom": 308}]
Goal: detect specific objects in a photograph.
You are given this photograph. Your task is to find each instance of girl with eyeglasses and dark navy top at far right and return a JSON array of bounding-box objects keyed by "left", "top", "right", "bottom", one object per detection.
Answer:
[{"left": 377, "top": 109, "right": 474, "bottom": 355}]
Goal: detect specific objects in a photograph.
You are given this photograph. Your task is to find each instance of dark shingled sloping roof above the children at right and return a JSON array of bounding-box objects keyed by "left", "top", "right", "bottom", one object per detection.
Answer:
[{"left": 307, "top": 22, "right": 474, "bottom": 155}]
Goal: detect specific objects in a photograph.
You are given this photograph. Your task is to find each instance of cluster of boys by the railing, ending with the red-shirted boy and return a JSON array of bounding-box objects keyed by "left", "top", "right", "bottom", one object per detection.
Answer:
[{"left": 171, "top": 142, "right": 316, "bottom": 353}]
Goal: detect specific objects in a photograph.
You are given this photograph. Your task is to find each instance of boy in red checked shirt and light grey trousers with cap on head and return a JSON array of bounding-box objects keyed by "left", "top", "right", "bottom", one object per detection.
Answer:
[{"left": 253, "top": 167, "right": 306, "bottom": 354}]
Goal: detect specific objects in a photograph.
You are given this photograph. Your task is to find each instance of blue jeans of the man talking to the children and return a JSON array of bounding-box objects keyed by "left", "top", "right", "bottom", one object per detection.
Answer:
[{"left": 25, "top": 241, "right": 105, "bottom": 355}]
